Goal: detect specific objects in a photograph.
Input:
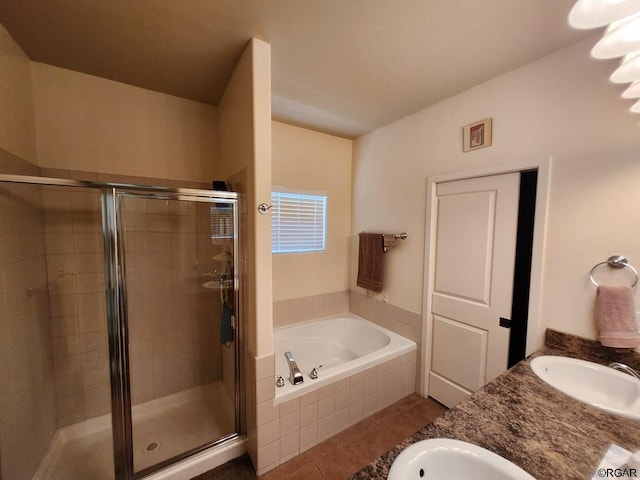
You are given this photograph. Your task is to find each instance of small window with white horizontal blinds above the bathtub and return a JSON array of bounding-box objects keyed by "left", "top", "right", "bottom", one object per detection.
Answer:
[{"left": 271, "top": 189, "right": 327, "bottom": 253}]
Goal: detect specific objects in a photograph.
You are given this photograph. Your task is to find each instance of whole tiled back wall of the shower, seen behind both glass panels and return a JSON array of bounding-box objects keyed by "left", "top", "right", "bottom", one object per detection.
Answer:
[{"left": 42, "top": 169, "right": 221, "bottom": 426}]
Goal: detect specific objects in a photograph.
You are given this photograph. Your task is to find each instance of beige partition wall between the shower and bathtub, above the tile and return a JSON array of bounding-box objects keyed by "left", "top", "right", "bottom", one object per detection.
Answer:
[{"left": 218, "top": 39, "right": 273, "bottom": 357}]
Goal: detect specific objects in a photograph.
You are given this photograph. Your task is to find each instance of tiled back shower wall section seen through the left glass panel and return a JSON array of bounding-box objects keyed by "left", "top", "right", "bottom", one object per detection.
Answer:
[{"left": 42, "top": 181, "right": 110, "bottom": 426}]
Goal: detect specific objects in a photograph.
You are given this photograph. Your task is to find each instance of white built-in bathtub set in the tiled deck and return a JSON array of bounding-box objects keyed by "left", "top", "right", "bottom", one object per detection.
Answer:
[{"left": 274, "top": 313, "right": 416, "bottom": 405}]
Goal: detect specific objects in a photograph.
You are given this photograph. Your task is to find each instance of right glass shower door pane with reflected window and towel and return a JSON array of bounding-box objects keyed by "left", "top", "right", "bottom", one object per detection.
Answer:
[{"left": 117, "top": 192, "right": 238, "bottom": 476}]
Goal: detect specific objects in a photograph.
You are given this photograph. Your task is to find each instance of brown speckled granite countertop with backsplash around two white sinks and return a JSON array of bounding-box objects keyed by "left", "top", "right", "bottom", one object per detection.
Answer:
[{"left": 351, "top": 330, "right": 640, "bottom": 480}]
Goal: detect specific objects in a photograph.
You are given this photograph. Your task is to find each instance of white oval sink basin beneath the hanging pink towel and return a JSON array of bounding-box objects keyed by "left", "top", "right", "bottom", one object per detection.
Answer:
[{"left": 531, "top": 355, "right": 640, "bottom": 420}]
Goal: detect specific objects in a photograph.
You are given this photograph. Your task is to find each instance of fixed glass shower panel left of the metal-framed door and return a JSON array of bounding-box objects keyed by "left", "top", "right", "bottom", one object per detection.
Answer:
[{"left": 0, "top": 179, "right": 114, "bottom": 480}]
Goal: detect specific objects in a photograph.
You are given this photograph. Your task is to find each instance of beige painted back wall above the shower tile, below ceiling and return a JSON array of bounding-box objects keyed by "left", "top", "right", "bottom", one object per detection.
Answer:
[{"left": 33, "top": 62, "right": 217, "bottom": 182}]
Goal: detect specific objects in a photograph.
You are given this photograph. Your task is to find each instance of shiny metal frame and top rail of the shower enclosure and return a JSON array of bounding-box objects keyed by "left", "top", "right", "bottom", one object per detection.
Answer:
[{"left": 0, "top": 174, "right": 242, "bottom": 480}]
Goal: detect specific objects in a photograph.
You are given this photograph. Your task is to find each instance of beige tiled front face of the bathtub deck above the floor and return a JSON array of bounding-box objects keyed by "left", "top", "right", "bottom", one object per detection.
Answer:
[{"left": 248, "top": 351, "right": 416, "bottom": 475}]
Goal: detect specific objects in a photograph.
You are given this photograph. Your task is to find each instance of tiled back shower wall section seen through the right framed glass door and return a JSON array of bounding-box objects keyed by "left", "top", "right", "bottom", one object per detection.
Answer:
[{"left": 123, "top": 198, "right": 224, "bottom": 404}]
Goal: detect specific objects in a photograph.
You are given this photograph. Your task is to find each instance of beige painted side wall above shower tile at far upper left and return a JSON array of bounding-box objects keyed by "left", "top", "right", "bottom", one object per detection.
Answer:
[{"left": 0, "top": 25, "right": 38, "bottom": 165}]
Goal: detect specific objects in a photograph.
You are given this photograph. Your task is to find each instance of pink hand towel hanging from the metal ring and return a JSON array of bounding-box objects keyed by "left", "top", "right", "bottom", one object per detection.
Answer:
[{"left": 595, "top": 286, "right": 640, "bottom": 348}]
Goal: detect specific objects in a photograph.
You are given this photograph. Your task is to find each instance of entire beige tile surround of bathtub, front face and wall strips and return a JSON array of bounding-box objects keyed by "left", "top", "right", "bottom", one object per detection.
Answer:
[{"left": 260, "top": 291, "right": 421, "bottom": 474}]
